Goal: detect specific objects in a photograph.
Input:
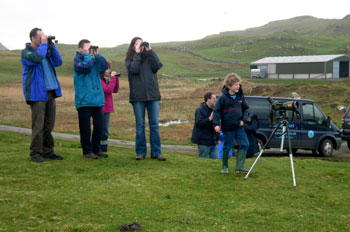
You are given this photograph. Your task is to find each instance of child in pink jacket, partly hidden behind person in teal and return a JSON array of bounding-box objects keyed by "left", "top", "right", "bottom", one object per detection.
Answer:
[{"left": 100, "top": 68, "right": 120, "bottom": 157}]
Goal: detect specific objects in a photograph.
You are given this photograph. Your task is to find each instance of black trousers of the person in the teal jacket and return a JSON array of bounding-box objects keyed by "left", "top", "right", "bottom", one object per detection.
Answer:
[{"left": 78, "top": 107, "right": 103, "bottom": 155}]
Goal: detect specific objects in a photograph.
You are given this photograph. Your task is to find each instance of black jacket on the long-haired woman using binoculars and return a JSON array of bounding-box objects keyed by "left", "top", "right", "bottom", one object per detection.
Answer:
[{"left": 125, "top": 50, "right": 163, "bottom": 102}]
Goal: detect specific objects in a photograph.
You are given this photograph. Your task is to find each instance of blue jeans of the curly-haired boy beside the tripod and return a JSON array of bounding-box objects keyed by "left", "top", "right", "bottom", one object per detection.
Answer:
[{"left": 223, "top": 126, "right": 249, "bottom": 153}]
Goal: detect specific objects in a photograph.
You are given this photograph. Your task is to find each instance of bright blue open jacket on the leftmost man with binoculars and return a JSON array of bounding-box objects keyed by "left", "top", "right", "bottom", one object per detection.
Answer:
[{"left": 21, "top": 43, "right": 62, "bottom": 104}]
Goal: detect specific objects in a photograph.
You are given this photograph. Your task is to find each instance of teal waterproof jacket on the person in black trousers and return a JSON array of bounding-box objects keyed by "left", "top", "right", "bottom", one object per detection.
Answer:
[{"left": 74, "top": 52, "right": 108, "bottom": 109}]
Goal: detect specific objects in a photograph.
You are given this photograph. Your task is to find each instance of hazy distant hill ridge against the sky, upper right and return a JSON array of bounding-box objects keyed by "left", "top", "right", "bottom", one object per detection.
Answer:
[{"left": 206, "top": 14, "right": 350, "bottom": 38}]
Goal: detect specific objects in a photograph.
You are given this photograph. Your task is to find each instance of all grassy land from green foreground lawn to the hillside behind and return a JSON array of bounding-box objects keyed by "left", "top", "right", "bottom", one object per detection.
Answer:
[{"left": 0, "top": 22, "right": 350, "bottom": 232}]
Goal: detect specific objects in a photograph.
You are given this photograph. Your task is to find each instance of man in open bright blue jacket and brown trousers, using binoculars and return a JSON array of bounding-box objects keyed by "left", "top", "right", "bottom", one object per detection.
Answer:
[{"left": 21, "top": 28, "right": 63, "bottom": 162}]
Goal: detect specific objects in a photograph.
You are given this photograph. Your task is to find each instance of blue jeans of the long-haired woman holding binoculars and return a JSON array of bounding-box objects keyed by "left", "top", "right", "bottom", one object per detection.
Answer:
[{"left": 132, "top": 101, "right": 162, "bottom": 157}]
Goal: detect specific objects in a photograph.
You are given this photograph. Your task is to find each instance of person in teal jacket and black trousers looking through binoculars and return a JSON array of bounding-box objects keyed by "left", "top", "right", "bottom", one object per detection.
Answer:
[{"left": 74, "top": 39, "right": 108, "bottom": 159}]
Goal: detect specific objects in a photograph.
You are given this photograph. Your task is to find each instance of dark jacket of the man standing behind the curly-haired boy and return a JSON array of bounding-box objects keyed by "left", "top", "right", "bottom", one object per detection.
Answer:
[{"left": 191, "top": 102, "right": 220, "bottom": 146}]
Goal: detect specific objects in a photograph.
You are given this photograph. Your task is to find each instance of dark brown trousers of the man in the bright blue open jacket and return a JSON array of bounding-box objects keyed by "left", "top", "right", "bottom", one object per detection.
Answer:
[{"left": 29, "top": 91, "right": 56, "bottom": 156}]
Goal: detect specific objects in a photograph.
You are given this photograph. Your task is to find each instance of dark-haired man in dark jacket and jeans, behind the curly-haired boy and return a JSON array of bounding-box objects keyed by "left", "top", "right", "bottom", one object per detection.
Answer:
[{"left": 191, "top": 92, "right": 220, "bottom": 159}]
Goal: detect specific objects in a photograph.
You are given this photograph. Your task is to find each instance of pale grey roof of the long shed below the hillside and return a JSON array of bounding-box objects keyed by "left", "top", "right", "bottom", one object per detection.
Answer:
[{"left": 250, "top": 54, "right": 349, "bottom": 65}]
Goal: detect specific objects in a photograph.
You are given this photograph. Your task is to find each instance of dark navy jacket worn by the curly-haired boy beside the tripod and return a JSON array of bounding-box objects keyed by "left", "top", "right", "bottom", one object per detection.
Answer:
[{"left": 213, "top": 86, "right": 249, "bottom": 132}]
